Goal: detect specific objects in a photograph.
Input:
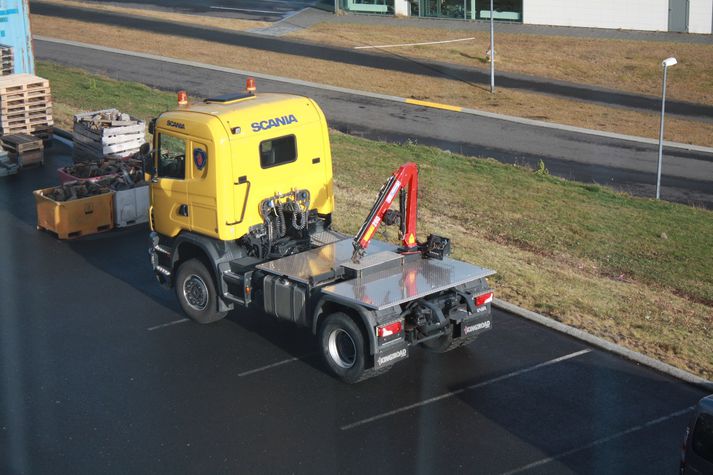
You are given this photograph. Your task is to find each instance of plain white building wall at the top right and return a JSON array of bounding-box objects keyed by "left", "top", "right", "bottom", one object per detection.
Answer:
[{"left": 523, "top": 0, "right": 668, "bottom": 31}]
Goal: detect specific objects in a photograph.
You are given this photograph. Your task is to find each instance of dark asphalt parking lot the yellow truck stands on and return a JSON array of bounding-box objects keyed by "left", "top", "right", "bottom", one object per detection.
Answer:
[{"left": 0, "top": 144, "right": 703, "bottom": 475}]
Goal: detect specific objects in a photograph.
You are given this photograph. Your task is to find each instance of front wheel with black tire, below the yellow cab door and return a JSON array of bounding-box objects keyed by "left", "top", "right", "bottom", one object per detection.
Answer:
[{"left": 176, "top": 259, "right": 228, "bottom": 323}]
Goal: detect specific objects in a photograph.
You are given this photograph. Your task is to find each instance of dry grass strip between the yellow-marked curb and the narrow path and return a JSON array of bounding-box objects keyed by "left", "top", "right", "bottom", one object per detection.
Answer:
[{"left": 32, "top": 15, "right": 713, "bottom": 146}]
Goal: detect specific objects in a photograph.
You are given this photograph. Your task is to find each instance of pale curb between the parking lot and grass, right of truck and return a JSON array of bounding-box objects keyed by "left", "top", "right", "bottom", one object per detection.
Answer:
[{"left": 493, "top": 298, "right": 713, "bottom": 392}]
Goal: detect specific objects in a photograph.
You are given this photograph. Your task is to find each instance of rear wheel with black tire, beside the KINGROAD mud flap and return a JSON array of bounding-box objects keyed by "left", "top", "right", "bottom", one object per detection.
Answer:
[{"left": 319, "top": 312, "right": 369, "bottom": 384}]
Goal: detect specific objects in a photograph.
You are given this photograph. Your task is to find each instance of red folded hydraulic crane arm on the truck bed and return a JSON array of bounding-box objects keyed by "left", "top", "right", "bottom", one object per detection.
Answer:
[{"left": 352, "top": 162, "right": 418, "bottom": 261}]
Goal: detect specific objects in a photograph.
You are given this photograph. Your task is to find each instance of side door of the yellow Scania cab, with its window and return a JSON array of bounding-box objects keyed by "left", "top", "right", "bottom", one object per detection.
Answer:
[{"left": 151, "top": 130, "right": 191, "bottom": 237}]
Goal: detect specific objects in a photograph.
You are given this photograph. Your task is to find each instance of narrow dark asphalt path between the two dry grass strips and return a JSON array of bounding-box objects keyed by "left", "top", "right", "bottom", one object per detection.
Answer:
[{"left": 32, "top": 1, "right": 713, "bottom": 121}]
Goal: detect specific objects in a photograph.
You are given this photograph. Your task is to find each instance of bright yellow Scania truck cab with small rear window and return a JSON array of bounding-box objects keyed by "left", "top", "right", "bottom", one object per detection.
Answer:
[{"left": 151, "top": 94, "right": 334, "bottom": 241}]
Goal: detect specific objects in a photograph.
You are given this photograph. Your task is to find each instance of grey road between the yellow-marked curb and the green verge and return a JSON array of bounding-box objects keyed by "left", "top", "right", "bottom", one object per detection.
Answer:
[{"left": 35, "top": 40, "right": 713, "bottom": 208}]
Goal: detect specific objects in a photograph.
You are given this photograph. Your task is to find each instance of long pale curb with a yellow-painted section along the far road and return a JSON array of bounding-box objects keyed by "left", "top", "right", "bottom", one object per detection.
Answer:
[{"left": 32, "top": 35, "right": 713, "bottom": 154}]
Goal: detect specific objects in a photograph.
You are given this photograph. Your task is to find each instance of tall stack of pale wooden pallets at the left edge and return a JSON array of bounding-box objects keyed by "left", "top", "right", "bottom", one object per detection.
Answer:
[{"left": 0, "top": 74, "right": 53, "bottom": 140}]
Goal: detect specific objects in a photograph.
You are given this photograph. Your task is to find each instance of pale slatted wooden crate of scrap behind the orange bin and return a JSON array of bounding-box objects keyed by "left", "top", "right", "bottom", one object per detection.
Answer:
[{"left": 72, "top": 109, "right": 146, "bottom": 161}]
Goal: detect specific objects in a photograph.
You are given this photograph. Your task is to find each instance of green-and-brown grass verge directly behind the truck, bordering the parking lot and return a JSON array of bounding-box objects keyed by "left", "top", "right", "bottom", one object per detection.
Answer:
[{"left": 38, "top": 63, "right": 713, "bottom": 378}]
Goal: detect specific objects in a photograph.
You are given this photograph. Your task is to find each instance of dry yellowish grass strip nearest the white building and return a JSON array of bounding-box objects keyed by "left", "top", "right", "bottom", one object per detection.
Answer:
[{"left": 290, "top": 23, "right": 713, "bottom": 104}]
